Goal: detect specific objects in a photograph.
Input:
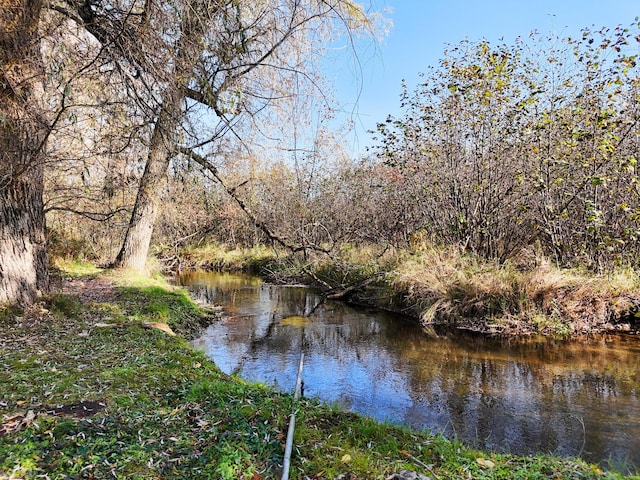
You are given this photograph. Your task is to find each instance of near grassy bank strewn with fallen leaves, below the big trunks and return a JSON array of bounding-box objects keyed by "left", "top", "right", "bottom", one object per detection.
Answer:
[{"left": 0, "top": 268, "right": 640, "bottom": 480}]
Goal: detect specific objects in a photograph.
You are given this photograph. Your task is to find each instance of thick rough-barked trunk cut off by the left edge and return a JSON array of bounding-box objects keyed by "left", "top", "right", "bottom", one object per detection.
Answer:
[{"left": 0, "top": 0, "right": 48, "bottom": 304}]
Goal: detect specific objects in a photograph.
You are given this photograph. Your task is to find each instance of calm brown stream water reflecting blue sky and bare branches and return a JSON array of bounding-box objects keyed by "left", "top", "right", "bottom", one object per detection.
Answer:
[{"left": 180, "top": 273, "right": 640, "bottom": 471}]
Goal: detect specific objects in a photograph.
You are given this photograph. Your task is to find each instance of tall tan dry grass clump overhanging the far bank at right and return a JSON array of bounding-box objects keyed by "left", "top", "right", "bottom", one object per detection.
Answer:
[{"left": 392, "top": 245, "right": 640, "bottom": 334}]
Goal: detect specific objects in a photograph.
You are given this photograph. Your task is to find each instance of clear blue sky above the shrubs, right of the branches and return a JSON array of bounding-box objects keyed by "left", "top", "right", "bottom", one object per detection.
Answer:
[{"left": 325, "top": 0, "right": 640, "bottom": 154}]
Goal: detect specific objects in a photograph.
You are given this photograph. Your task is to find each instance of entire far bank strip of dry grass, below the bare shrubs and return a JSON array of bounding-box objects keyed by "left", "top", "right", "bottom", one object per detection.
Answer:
[{"left": 172, "top": 243, "right": 640, "bottom": 337}]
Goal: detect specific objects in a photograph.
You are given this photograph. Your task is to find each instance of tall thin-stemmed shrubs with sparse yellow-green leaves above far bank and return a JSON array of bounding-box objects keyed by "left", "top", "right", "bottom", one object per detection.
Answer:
[{"left": 377, "top": 24, "right": 640, "bottom": 269}]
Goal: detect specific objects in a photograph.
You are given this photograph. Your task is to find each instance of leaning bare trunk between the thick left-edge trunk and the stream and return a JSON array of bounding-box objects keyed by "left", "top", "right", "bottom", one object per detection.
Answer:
[{"left": 114, "top": 4, "right": 206, "bottom": 270}]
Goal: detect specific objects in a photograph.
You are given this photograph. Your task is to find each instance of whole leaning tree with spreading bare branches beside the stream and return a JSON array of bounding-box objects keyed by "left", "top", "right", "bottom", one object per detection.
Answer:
[{"left": 64, "top": 0, "right": 382, "bottom": 269}]
